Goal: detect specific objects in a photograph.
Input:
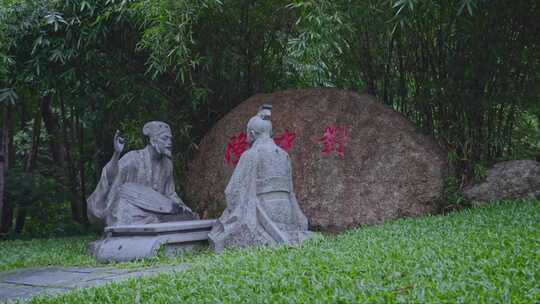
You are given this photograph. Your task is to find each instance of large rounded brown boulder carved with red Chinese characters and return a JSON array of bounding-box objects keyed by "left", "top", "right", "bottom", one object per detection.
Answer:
[{"left": 186, "top": 89, "right": 447, "bottom": 232}]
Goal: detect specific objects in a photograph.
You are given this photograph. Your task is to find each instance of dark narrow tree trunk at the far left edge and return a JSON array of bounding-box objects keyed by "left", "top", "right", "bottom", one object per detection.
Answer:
[{"left": 0, "top": 106, "right": 13, "bottom": 233}]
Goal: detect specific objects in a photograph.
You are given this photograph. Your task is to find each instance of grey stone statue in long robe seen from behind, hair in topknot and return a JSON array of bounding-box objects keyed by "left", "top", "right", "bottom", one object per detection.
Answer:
[{"left": 208, "top": 105, "right": 310, "bottom": 252}]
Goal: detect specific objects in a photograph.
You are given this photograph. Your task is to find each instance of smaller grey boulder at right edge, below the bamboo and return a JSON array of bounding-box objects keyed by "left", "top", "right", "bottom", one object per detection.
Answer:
[{"left": 463, "top": 160, "right": 540, "bottom": 202}]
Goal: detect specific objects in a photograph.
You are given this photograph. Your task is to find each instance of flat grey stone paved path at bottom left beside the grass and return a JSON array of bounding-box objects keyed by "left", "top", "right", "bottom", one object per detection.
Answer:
[{"left": 0, "top": 264, "right": 188, "bottom": 303}]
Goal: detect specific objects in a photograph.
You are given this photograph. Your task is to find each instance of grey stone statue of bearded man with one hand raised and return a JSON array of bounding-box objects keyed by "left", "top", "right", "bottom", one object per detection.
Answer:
[{"left": 87, "top": 121, "right": 198, "bottom": 226}]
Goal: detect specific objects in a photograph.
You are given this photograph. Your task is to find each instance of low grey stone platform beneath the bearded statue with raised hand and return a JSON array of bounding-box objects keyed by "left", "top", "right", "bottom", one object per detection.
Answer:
[{"left": 89, "top": 220, "right": 215, "bottom": 262}]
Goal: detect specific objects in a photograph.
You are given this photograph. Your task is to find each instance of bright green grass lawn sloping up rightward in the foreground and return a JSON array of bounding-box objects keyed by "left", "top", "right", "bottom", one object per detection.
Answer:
[{"left": 19, "top": 201, "right": 540, "bottom": 303}]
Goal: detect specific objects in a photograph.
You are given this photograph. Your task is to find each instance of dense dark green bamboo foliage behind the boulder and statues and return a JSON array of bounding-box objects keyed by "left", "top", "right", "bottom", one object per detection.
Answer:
[{"left": 0, "top": 0, "right": 540, "bottom": 233}]
